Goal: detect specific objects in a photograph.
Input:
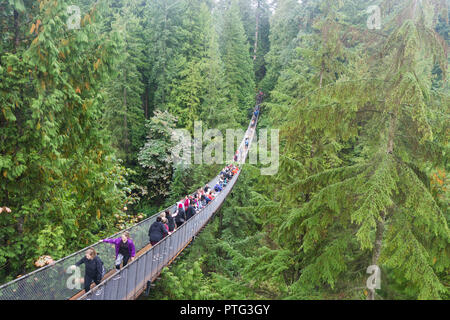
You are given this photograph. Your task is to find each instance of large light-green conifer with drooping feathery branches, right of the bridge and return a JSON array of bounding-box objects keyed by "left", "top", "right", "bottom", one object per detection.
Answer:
[{"left": 266, "top": 1, "right": 450, "bottom": 299}]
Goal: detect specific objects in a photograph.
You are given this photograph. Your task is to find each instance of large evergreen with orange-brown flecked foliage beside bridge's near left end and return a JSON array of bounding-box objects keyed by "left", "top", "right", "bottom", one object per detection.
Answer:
[{"left": 0, "top": 1, "right": 131, "bottom": 279}]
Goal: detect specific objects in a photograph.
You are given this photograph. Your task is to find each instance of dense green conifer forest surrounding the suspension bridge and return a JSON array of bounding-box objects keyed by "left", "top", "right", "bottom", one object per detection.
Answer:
[{"left": 0, "top": 0, "right": 450, "bottom": 300}]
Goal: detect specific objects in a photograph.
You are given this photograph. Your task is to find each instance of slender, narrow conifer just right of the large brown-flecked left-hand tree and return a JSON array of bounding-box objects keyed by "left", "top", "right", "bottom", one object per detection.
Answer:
[{"left": 101, "top": 0, "right": 145, "bottom": 166}]
